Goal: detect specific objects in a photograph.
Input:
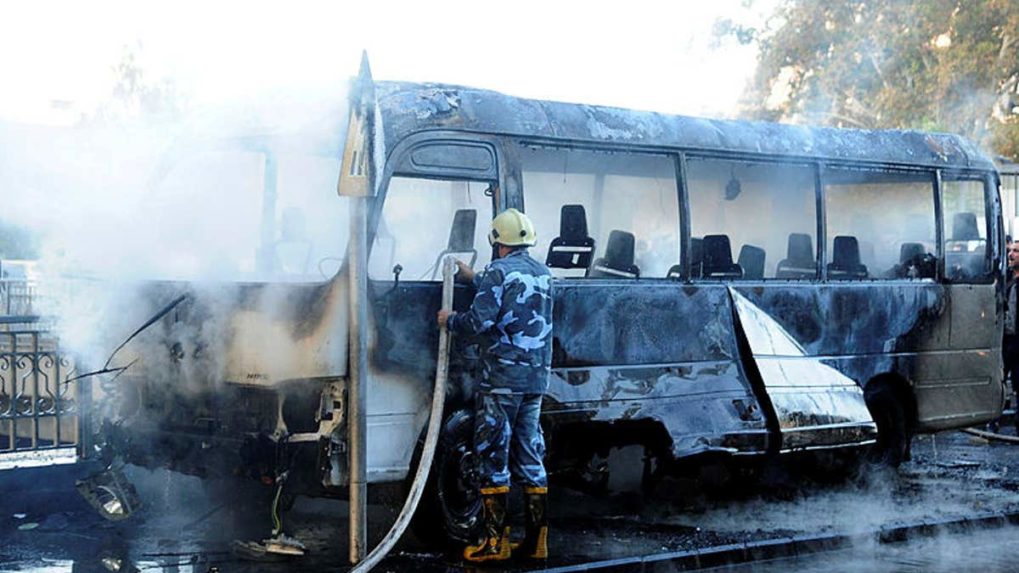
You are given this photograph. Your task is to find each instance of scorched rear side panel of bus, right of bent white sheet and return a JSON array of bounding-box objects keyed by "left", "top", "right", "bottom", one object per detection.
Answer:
[{"left": 734, "top": 280, "right": 1003, "bottom": 430}]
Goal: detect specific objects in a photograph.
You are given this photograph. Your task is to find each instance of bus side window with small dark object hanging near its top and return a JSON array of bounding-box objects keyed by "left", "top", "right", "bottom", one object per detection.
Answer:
[{"left": 687, "top": 157, "right": 817, "bottom": 279}]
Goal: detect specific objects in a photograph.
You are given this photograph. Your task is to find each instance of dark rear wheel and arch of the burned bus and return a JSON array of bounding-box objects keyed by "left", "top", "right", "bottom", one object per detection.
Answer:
[{"left": 863, "top": 372, "right": 917, "bottom": 468}]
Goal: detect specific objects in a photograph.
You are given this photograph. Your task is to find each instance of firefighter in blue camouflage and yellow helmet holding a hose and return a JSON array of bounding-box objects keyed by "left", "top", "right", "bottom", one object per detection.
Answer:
[{"left": 437, "top": 209, "right": 552, "bottom": 562}]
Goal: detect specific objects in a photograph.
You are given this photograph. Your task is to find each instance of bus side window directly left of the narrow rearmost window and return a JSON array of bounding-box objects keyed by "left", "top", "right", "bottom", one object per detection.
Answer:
[{"left": 822, "top": 168, "right": 937, "bottom": 280}]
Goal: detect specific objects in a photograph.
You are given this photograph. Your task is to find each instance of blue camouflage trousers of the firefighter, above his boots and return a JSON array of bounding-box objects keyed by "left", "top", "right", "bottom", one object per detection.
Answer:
[{"left": 474, "top": 392, "right": 548, "bottom": 489}]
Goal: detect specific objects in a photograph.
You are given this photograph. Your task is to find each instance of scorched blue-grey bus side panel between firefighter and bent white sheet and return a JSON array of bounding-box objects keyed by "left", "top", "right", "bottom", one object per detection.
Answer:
[{"left": 547, "top": 281, "right": 767, "bottom": 458}]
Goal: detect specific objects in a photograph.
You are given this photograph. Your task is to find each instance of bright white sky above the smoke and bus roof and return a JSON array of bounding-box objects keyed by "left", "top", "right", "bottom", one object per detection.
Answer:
[{"left": 0, "top": 0, "right": 776, "bottom": 123}]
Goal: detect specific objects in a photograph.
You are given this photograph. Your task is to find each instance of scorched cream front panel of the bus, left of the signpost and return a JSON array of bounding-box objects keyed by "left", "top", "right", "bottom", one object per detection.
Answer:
[{"left": 110, "top": 277, "right": 347, "bottom": 387}]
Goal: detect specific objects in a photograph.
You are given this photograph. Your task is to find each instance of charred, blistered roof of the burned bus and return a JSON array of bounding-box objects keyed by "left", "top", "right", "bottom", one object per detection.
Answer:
[{"left": 375, "top": 82, "right": 995, "bottom": 170}]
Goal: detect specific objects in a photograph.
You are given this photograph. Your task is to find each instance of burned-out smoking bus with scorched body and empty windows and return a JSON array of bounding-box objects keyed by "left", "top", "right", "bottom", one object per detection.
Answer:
[{"left": 7, "top": 60, "right": 1005, "bottom": 538}]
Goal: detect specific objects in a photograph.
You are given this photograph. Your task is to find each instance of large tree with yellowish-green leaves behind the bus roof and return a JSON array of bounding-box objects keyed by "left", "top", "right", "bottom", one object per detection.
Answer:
[{"left": 737, "top": 0, "right": 1019, "bottom": 160}]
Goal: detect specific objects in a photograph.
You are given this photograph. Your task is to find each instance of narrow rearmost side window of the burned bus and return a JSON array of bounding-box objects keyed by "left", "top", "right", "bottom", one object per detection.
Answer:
[{"left": 942, "top": 176, "right": 990, "bottom": 281}]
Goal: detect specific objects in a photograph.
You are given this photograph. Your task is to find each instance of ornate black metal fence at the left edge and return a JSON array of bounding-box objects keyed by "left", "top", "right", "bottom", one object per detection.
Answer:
[{"left": 0, "top": 280, "right": 82, "bottom": 460}]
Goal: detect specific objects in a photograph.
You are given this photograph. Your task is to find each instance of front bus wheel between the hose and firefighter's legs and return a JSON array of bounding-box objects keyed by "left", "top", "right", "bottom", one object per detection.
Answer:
[{"left": 412, "top": 410, "right": 481, "bottom": 548}]
